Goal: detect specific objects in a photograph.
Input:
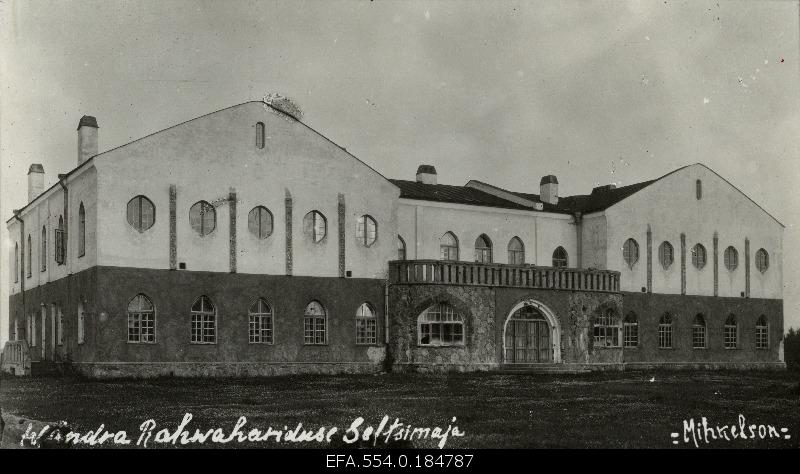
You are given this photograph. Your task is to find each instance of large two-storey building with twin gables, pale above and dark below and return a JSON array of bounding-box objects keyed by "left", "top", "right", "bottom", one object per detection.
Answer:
[{"left": 5, "top": 102, "right": 784, "bottom": 377}]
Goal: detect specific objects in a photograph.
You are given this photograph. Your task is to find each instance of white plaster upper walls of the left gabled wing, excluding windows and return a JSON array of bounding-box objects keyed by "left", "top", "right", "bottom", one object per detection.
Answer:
[{"left": 8, "top": 102, "right": 399, "bottom": 294}]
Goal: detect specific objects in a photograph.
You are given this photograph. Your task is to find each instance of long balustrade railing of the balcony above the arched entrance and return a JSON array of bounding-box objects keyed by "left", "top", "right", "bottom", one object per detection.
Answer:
[{"left": 389, "top": 260, "right": 619, "bottom": 292}]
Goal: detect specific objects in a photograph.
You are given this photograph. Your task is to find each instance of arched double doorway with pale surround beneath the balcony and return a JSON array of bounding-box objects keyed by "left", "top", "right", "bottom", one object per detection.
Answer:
[{"left": 503, "top": 300, "right": 561, "bottom": 364}]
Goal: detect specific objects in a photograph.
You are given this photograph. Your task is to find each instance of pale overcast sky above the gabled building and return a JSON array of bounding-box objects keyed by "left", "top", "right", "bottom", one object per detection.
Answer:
[{"left": 0, "top": 0, "right": 800, "bottom": 341}]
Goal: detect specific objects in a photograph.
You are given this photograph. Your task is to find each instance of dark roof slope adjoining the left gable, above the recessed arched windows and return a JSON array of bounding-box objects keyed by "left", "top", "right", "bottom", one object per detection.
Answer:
[{"left": 389, "top": 179, "right": 531, "bottom": 210}]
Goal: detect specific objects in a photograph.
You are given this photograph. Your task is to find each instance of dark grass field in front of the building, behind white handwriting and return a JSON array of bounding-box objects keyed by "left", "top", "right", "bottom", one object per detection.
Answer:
[{"left": 0, "top": 372, "right": 800, "bottom": 448}]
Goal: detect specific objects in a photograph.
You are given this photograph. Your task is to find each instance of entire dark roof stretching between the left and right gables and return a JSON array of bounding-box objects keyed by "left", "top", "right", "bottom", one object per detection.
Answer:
[{"left": 389, "top": 178, "right": 661, "bottom": 214}]
